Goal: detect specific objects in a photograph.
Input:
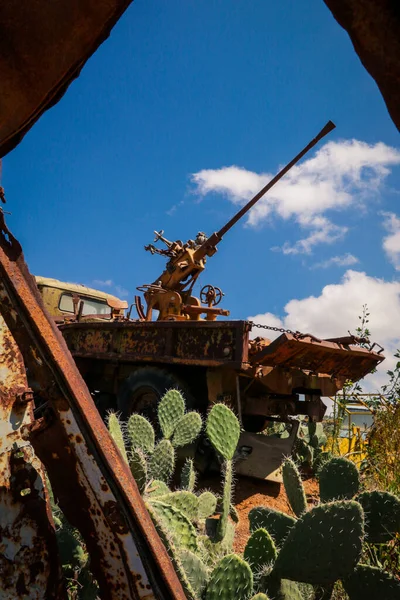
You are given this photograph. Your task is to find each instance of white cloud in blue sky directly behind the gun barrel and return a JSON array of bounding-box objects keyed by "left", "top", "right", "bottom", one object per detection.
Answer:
[{"left": 191, "top": 140, "right": 400, "bottom": 254}]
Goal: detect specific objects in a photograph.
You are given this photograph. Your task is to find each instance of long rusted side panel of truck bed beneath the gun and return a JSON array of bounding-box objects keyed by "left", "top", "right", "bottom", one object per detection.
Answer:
[{"left": 60, "top": 321, "right": 249, "bottom": 368}]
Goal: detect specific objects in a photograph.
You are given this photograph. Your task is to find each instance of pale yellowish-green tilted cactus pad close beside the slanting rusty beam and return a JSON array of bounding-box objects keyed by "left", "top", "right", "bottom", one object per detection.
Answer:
[{"left": 146, "top": 500, "right": 199, "bottom": 552}]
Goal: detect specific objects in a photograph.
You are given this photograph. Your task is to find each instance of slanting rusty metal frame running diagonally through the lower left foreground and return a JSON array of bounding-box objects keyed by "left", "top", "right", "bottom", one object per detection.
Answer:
[{"left": 0, "top": 214, "right": 185, "bottom": 600}]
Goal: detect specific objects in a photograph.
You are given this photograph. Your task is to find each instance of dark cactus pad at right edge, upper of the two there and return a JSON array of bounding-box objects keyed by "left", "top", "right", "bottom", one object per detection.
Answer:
[{"left": 357, "top": 491, "right": 400, "bottom": 544}]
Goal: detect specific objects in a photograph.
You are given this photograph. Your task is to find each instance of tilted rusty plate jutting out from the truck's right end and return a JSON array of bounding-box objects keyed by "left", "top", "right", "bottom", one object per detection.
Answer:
[{"left": 250, "top": 333, "right": 385, "bottom": 381}]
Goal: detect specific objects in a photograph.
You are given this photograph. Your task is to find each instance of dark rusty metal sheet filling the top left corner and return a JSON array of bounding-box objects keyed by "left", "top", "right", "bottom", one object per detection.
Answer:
[{"left": 0, "top": 0, "right": 132, "bottom": 157}]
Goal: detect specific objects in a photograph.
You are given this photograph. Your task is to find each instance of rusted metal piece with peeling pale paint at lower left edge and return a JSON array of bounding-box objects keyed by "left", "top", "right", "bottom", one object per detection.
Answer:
[{"left": 0, "top": 316, "right": 66, "bottom": 600}]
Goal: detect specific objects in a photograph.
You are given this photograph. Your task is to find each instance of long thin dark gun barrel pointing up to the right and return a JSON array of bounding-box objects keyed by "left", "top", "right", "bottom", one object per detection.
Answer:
[{"left": 202, "top": 121, "right": 336, "bottom": 256}]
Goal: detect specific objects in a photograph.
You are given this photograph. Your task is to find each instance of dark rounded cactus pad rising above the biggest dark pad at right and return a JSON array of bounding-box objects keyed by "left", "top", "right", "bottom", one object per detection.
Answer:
[{"left": 319, "top": 458, "right": 360, "bottom": 502}]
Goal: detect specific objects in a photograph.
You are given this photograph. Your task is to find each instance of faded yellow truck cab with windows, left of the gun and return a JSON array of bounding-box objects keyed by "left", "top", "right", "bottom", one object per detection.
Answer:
[{"left": 35, "top": 276, "right": 128, "bottom": 322}]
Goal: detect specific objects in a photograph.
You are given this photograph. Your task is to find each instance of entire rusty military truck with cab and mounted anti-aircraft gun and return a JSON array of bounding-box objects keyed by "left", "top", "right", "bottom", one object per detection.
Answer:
[{"left": 37, "top": 122, "right": 384, "bottom": 481}]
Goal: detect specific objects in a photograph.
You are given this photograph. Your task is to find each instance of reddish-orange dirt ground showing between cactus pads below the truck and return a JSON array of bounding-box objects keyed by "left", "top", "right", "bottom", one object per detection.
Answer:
[{"left": 200, "top": 473, "right": 318, "bottom": 552}]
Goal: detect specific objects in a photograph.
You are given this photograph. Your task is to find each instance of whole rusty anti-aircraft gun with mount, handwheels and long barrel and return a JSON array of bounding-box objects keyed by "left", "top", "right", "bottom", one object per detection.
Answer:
[{"left": 136, "top": 121, "right": 335, "bottom": 321}]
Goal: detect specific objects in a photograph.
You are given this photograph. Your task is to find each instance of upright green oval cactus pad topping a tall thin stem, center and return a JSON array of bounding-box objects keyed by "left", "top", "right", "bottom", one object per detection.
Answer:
[{"left": 206, "top": 404, "right": 240, "bottom": 460}]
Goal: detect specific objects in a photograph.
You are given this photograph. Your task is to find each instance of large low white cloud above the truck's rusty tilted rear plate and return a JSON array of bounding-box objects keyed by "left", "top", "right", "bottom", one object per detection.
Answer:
[{"left": 249, "top": 270, "right": 400, "bottom": 391}]
